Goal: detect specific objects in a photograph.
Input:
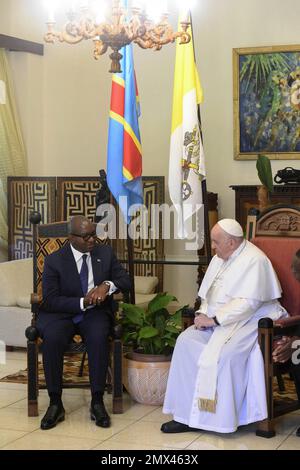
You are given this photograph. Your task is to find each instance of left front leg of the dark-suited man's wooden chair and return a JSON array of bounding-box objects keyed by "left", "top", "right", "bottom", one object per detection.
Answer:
[{"left": 27, "top": 341, "right": 39, "bottom": 416}]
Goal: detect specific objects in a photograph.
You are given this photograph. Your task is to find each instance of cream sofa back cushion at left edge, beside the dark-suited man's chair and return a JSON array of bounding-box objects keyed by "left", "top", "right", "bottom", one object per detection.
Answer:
[{"left": 0, "top": 258, "right": 33, "bottom": 308}]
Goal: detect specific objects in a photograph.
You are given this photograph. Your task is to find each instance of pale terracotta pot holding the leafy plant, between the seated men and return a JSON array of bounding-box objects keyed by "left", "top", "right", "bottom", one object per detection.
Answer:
[{"left": 123, "top": 352, "right": 171, "bottom": 405}]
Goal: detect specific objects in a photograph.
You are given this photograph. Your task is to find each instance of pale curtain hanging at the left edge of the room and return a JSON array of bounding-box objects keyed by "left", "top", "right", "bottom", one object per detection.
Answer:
[{"left": 0, "top": 49, "right": 27, "bottom": 247}]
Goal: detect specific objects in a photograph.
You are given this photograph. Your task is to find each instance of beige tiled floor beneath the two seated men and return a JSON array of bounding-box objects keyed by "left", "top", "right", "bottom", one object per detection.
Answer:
[{"left": 0, "top": 352, "right": 300, "bottom": 450}]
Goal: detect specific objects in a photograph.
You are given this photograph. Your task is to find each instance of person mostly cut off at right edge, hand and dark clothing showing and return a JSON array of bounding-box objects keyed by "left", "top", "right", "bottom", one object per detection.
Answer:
[{"left": 273, "top": 250, "right": 300, "bottom": 437}]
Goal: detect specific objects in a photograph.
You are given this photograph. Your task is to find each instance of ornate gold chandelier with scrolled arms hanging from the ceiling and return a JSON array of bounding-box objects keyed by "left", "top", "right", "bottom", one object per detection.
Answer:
[{"left": 44, "top": 0, "right": 191, "bottom": 73}]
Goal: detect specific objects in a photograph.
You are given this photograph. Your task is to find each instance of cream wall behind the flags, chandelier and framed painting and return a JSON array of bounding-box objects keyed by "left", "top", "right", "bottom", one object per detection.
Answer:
[{"left": 0, "top": 0, "right": 300, "bottom": 301}]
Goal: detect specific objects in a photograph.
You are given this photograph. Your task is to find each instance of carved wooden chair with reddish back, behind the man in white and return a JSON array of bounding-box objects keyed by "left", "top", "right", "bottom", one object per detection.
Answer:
[{"left": 247, "top": 204, "right": 300, "bottom": 437}]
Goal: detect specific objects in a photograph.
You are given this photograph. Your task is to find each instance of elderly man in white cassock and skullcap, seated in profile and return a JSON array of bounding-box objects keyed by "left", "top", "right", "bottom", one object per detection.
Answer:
[{"left": 161, "top": 219, "right": 287, "bottom": 433}]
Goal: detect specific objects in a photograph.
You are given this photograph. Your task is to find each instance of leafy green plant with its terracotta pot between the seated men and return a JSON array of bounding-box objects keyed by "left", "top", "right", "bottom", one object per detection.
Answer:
[{"left": 120, "top": 293, "right": 186, "bottom": 405}]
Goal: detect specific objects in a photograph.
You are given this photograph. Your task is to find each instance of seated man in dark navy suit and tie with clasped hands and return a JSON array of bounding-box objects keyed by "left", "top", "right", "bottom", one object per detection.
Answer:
[{"left": 37, "top": 216, "right": 130, "bottom": 429}]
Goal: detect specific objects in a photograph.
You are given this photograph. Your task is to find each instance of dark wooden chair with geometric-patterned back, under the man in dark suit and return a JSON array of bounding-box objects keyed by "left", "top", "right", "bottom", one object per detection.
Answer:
[{"left": 25, "top": 213, "right": 123, "bottom": 416}]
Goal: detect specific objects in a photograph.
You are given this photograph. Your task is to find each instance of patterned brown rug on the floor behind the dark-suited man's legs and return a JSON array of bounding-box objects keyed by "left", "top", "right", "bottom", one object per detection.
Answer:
[{"left": 0, "top": 354, "right": 89, "bottom": 387}]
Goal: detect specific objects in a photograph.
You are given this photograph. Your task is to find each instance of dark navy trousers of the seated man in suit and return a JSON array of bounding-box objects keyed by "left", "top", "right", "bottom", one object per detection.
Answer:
[{"left": 38, "top": 310, "right": 111, "bottom": 394}]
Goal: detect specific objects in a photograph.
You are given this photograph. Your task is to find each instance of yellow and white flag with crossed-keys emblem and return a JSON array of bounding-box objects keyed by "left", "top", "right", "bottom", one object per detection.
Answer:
[{"left": 169, "top": 16, "right": 205, "bottom": 238}]
